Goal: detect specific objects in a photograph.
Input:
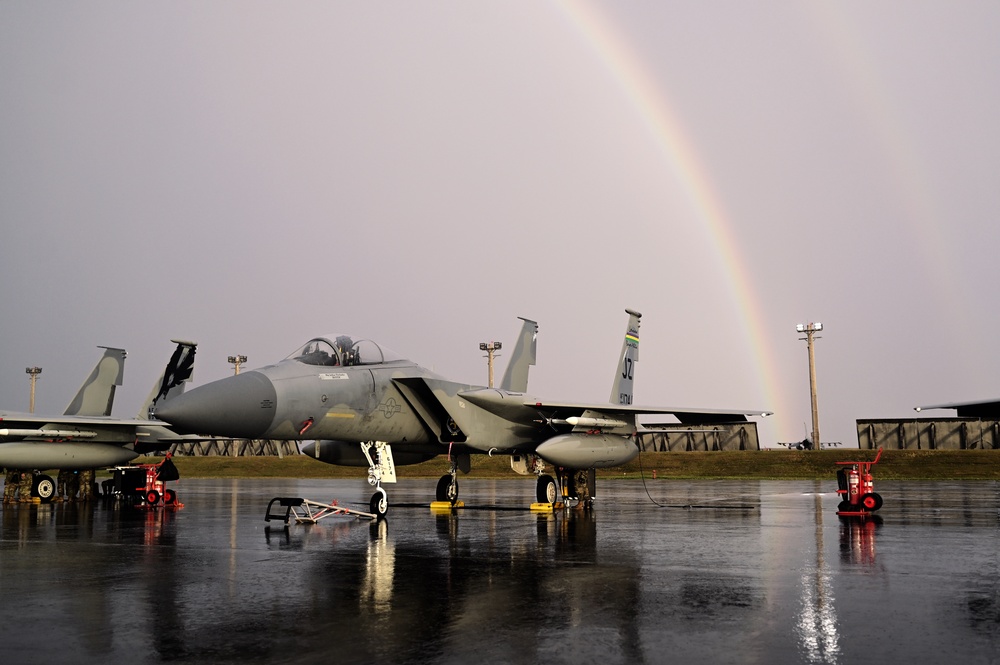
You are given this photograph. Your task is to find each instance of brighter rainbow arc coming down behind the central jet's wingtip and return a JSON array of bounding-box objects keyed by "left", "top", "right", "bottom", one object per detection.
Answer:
[{"left": 555, "top": 0, "right": 788, "bottom": 430}]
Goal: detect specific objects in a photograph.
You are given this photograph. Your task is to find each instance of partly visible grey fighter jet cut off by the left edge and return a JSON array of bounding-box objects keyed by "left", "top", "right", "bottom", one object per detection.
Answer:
[{"left": 0, "top": 340, "right": 197, "bottom": 501}]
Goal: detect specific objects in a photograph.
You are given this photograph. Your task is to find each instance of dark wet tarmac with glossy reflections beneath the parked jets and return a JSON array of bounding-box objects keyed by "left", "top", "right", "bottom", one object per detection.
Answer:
[{"left": 0, "top": 479, "right": 1000, "bottom": 665}]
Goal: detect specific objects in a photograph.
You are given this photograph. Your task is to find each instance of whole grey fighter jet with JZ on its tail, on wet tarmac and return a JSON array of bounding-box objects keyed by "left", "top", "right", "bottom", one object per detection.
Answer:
[{"left": 154, "top": 310, "right": 768, "bottom": 516}]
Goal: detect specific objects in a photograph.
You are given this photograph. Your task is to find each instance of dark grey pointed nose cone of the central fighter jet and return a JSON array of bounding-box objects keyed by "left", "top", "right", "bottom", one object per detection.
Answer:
[{"left": 155, "top": 372, "right": 278, "bottom": 439}]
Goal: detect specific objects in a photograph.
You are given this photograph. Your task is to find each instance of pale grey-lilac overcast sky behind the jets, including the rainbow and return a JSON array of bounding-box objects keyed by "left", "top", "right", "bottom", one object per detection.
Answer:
[{"left": 0, "top": 0, "right": 1000, "bottom": 446}]
